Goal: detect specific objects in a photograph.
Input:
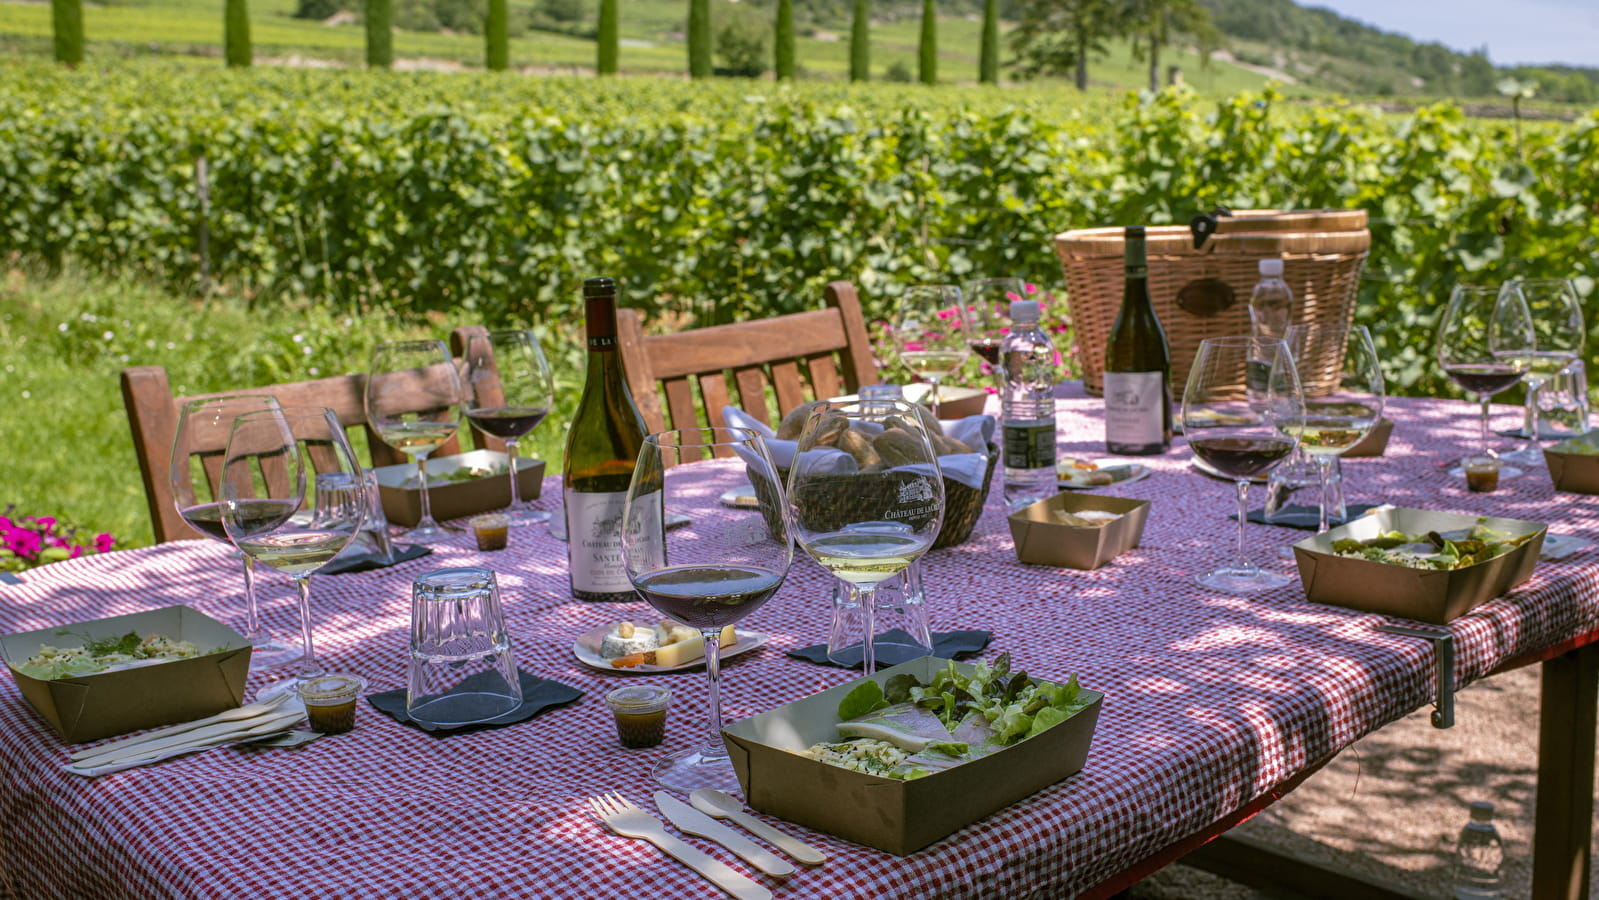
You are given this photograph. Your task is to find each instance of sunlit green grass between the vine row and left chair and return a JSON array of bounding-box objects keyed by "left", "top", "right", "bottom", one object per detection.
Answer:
[{"left": 0, "top": 270, "right": 582, "bottom": 545}]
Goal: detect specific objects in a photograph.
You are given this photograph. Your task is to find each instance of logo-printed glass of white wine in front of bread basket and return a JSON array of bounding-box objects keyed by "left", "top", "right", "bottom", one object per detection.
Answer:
[{"left": 788, "top": 400, "right": 943, "bottom": 675}]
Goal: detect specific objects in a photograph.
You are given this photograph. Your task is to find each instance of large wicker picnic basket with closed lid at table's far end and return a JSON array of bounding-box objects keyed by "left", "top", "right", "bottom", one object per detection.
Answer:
[{"left": 1055, "top": 209, "right": 1372, "bottom": 400}]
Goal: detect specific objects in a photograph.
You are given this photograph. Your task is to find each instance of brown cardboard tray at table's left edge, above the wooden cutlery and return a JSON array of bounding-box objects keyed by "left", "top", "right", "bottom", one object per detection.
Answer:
[{"left": 0, "top": 606, "right": 249, "bottom": 743}]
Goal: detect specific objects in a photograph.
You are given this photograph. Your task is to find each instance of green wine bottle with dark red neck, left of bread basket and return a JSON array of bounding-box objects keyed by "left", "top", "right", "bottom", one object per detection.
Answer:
[{"left": 561, "top": 278, "right": 644, "bottom": 603}]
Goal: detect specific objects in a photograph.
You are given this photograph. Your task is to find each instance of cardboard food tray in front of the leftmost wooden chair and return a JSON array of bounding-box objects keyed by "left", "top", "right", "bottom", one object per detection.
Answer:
[{"left": 373, "top": 451, "right": 544, "bottom": 526}]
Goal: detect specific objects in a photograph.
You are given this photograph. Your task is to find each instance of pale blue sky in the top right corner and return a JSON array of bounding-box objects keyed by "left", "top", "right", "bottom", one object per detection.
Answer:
[{"left": 1297, "top": 0, "right": 1599, "bottom": 69}]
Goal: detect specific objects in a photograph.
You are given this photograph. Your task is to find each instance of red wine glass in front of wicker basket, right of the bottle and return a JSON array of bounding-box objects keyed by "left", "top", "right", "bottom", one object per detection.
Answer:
[{"left": 1182, "top": 337, "right": 1305, "bottom": 593}]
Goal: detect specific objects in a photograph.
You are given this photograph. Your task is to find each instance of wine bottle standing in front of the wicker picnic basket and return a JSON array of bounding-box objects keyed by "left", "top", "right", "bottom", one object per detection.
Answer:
[{"left": 1105, "top": 225, "right": 1172, "bottom": 456}]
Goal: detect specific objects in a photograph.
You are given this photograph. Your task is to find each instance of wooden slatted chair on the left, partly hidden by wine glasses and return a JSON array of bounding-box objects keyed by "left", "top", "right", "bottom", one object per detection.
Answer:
[{"left": 122, "top": 366, "right": 461, "bottom": 542}]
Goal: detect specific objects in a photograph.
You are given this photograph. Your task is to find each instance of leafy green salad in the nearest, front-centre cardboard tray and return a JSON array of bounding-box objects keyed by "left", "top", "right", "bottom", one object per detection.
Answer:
[{"left": 803, "top": 654, "right": 1091, "bottom": 780}]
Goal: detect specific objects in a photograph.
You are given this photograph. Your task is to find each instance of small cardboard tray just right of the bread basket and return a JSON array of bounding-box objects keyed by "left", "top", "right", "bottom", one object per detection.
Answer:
[{"left": 1006, "top": 494, "right": 1150, "bottom": 569}]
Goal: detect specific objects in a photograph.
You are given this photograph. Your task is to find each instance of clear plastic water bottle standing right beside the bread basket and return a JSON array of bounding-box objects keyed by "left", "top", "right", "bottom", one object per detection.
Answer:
[{"left": 999, "top": 301, "right": 1055, "bottom": 508}]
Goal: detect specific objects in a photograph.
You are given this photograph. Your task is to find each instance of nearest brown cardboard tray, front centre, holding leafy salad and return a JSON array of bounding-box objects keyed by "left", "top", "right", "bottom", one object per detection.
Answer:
[{"left": 721, "top": 657, "right": 1103, "bottom": 857}]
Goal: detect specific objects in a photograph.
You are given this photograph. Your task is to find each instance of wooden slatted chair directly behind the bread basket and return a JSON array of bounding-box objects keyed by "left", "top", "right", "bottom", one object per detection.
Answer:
[{"left": 617, "top": 281, "right": 878, "bottom": 450}]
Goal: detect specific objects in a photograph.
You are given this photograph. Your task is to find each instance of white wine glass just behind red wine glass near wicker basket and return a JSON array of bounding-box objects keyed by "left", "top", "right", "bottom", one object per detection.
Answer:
[{"left": 1279, "top": 323, "right": 1385, "bottom": 531}]
